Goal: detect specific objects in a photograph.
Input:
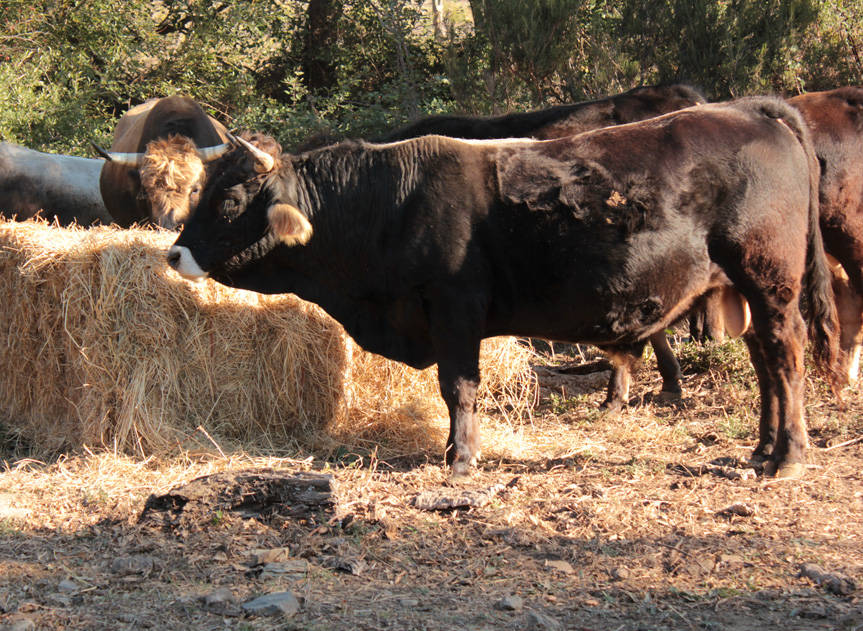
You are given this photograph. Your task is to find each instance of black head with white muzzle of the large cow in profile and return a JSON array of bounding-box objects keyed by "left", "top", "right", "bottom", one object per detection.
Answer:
[{"left": 168, "top": 135, "right": 312, "bottom": 284}]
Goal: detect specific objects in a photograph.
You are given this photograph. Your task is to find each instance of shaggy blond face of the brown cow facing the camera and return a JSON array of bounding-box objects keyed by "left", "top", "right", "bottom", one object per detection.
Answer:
[{"left": 140, "top": 136, "right": 206, "bottom": 230}]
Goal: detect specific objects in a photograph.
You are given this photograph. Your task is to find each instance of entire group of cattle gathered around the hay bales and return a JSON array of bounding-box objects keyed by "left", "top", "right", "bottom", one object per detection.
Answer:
[{"left": 0, "top": 85, "right": 863, "bottom": 477}]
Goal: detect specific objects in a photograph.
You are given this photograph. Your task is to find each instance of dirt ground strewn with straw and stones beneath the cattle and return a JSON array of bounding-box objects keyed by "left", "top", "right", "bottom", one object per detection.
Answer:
[{"left": 0, "top": 342, "right": 863, "bottom": 631}]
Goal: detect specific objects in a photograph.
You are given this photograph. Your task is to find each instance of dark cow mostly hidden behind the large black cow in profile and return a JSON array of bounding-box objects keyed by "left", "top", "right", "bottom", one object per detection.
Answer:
[{"left": 380, "top": 84, "right": 707, "bottom": 410}]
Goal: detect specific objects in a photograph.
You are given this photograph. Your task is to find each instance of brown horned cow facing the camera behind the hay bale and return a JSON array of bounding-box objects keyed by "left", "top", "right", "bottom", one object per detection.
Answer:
[{"left": 97, "top": 96, "right": 230, "bottom": 229}]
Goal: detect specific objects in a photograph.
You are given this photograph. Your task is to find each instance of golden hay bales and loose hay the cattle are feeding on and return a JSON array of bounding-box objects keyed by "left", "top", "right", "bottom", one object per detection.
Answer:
[{"left": 0, "top": 221, "right": 535, "bottom": 455}]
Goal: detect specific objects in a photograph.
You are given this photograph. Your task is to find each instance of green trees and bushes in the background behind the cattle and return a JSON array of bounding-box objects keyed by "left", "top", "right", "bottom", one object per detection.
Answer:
[{"left": 0, "top": 0, "right": 863, "bottom": 155}]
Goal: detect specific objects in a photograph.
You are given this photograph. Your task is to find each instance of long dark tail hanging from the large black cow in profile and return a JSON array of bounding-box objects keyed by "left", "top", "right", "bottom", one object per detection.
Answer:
[{"left": 776, "top": 100, "right": 847, "bottom": 396}]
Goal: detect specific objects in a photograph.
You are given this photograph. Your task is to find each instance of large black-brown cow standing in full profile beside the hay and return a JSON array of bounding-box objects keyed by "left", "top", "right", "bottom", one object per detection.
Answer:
[{"left": 168, "top": 98, "right": 838, "bottom": 476}]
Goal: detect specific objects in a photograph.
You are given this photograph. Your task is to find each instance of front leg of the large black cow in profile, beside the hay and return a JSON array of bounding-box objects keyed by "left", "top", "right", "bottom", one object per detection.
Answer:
[{"left": 438, "top": 356, "right": 480, "bottom": 476}]
